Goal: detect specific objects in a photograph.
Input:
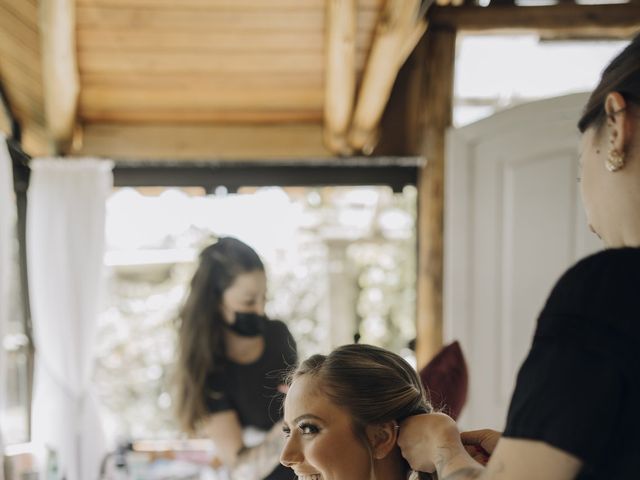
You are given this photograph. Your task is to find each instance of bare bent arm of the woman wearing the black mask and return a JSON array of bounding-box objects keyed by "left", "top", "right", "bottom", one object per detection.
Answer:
[{"left": 198, "top": 410, "right": 284, "bottom": 480}]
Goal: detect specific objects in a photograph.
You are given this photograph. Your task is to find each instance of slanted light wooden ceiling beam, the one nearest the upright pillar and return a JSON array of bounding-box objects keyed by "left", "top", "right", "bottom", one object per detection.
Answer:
[{"left": 349, "top": 0, "right": 427, "bottom": 154}]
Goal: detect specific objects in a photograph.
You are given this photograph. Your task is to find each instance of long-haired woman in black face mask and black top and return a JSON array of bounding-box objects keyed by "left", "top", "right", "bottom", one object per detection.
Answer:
[{"left": 177, "top": 237, "right": 297, "bottom": 480}]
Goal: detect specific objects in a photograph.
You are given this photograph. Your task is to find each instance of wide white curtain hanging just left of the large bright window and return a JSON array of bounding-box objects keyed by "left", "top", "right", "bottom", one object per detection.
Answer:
[{"left": 27, "top": 159, "right": 113, "bottom": 480}]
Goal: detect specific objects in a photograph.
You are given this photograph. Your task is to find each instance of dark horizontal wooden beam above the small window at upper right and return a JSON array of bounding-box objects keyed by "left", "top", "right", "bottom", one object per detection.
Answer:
[{"left": 428, "top": 3, "right": 640, "bottom": 38}]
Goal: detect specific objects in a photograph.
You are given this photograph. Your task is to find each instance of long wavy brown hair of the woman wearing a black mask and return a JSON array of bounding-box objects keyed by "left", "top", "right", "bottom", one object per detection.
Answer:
[{"left": 176, "top": 237, "right": 264, "bottom": 432}]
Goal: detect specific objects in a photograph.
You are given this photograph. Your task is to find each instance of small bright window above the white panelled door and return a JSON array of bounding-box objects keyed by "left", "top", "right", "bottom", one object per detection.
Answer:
[{"left": 453, "top": 34, "right": 628, "bottom": 127}]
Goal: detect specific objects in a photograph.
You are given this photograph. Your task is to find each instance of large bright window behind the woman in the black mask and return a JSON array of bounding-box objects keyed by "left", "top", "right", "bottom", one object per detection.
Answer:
[{"left": 95, "top": 182, "right": 417, "bottom": 439}]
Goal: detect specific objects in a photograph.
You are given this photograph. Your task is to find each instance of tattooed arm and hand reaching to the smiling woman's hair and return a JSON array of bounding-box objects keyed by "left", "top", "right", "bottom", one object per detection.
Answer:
[{"left": 398, "top": 414, "right": 581, "bottom": 480}]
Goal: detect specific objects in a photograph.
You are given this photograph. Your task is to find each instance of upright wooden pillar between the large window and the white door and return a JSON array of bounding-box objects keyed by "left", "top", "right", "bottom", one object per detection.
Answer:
[{"left": 416, "top": 28, "right": 456, "bottom": 368}]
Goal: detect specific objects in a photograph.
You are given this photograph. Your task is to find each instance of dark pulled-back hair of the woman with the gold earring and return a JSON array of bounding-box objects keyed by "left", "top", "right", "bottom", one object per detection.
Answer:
[{"left": 578, "top": 34, "right": 640, "bottom": 133}]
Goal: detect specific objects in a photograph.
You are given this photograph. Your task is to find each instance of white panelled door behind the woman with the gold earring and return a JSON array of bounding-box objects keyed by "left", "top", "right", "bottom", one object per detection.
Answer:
[{"left": 444, "top": 94, "right": 601, "bottom": 430}]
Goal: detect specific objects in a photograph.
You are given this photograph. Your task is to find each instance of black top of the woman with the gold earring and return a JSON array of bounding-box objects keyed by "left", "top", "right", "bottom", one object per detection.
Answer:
[{"left": 504, "top": 248, "right": 640, "bottom": 480}]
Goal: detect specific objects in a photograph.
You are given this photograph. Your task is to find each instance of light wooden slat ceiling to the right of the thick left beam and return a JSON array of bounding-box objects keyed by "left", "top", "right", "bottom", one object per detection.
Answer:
[{"left": 75, "top": 0, "right": 383, "bottom": 124}]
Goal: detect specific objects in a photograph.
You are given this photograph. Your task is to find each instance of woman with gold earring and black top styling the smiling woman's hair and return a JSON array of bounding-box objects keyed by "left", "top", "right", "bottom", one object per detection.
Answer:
[{"left": 399, "top": 35, "right": 640, "bottom": 480}]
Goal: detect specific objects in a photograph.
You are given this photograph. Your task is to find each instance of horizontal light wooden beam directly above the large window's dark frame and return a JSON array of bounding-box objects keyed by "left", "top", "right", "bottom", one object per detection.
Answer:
[{"left": 73, "top": 123, "right": 331, "bottom": 161}]
